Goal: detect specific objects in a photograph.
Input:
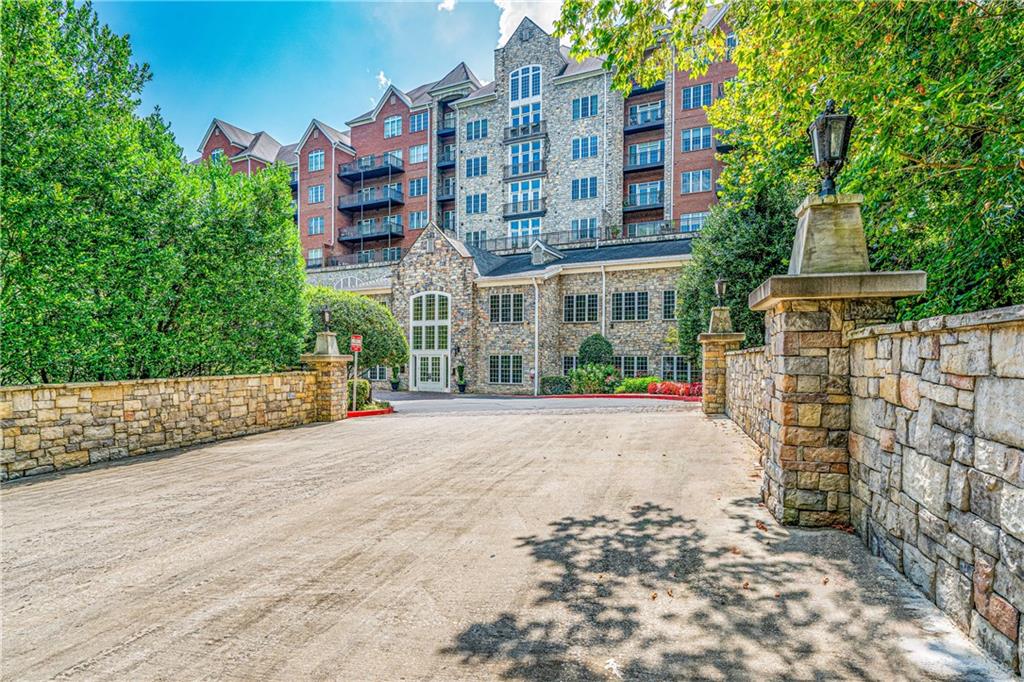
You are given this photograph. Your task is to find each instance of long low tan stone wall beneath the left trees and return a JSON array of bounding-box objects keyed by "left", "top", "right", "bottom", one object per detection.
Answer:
[{"left": 0, "top": 372, "right": 316, "bottom": 480}]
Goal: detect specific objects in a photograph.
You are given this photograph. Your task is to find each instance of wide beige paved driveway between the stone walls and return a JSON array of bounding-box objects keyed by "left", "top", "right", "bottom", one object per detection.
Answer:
[{"left": 0, "top": 401, "right": 1000, "bottom": 680}]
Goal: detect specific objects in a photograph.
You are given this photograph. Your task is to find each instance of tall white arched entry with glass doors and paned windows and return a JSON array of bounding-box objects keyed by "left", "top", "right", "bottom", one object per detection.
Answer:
[{"left": 409, "top": 291, "right": 452, "bottom": 391}]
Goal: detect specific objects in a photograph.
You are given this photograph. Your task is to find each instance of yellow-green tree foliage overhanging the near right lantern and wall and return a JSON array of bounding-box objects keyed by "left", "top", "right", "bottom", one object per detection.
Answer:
[{"left": 558, "top": 0, "right": 1024, "bottom": 317}]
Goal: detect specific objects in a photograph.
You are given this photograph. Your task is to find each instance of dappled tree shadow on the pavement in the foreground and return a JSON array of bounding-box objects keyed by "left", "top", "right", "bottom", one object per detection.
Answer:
[{"left": 441, "top": 498, "right": 983, "bottom": 680}]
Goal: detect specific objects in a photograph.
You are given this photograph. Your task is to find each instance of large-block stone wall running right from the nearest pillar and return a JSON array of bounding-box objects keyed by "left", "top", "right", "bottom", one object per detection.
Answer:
[{"left": 848, "top": 306, "right": 1024, "bottom": 671}]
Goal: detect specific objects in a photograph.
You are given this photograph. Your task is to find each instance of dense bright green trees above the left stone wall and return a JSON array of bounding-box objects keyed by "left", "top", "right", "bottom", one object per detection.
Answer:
[{"left": 0, "top": 1, "right": 306, "bottom": 384}]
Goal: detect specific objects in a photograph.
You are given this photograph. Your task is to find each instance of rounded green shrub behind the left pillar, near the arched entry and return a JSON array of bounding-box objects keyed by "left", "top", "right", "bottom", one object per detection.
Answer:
[{"left": 306, "top": 287, "right": 409, "bottom": 369}]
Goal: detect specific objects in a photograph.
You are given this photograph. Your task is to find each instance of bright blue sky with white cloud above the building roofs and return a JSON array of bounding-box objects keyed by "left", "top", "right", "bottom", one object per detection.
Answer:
[{"left": 94, "top": 0, "right": 559, "bottom": 159}]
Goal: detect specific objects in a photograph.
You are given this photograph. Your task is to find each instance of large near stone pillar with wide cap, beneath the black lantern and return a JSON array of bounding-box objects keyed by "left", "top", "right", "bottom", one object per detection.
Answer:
[{"left": 749, "top": 195, "right": 926, "bottom": 526}]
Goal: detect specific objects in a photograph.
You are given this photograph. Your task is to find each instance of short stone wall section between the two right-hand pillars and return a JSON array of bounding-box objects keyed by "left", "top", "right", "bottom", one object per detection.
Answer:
[{"left": 725, "top": 346, "right": 771, "bottom": 452}]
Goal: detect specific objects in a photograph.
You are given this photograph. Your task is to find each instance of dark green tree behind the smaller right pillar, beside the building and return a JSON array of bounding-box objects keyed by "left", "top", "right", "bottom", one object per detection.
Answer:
[{"left": 678, "top": 185, "right": 797, "bottom": 358}]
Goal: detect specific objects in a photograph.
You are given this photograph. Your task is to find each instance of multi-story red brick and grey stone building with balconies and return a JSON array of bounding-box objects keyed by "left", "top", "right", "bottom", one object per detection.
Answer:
[{"left": 193, "top": 6, "right": 736, "bottom": 392}]
